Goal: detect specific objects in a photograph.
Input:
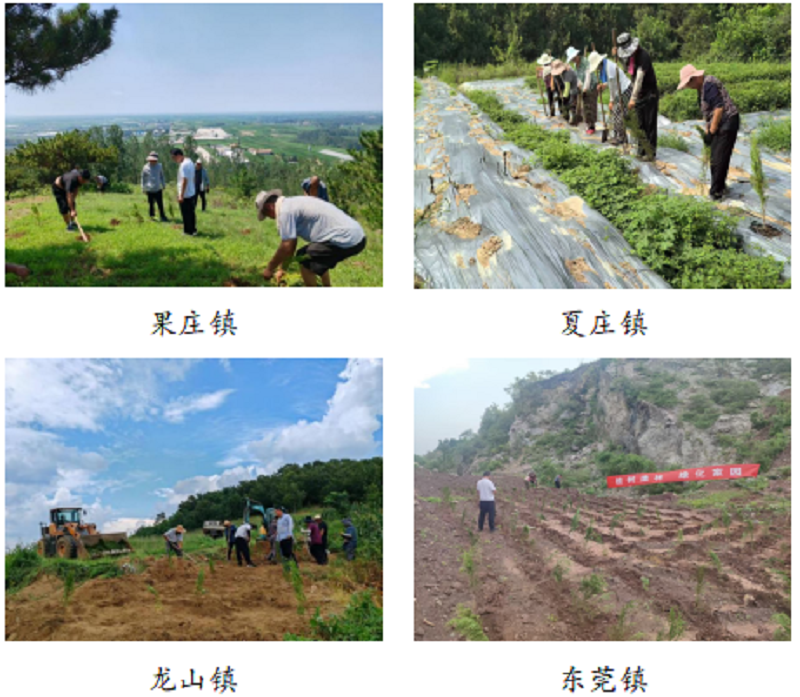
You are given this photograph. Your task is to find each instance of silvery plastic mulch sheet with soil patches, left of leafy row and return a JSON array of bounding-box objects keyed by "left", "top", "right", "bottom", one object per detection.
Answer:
[{"left": 414, "top": 80, "right": 669, "bottom": 288}]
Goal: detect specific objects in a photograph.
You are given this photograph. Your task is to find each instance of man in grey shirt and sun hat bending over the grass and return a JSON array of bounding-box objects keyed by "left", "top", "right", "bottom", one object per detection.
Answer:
[{"left": 256, "top": 189, "right": 367, "bottom": 287}]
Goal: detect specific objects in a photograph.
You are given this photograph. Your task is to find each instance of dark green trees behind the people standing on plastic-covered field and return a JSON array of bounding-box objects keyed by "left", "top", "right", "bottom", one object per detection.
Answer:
[{"left": 414, "top": 3, "right": 792, "bottom": 71}]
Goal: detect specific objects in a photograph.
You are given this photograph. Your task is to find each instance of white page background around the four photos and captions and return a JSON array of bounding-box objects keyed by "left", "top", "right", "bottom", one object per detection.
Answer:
[{"left": 0, "top": 0, "right": 798, "bottom": 697}]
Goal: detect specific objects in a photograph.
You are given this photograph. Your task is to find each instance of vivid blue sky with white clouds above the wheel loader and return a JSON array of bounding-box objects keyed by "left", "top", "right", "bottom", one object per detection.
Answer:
[{"left": 6, "top": 359, "right": 383, "bottom": 546}]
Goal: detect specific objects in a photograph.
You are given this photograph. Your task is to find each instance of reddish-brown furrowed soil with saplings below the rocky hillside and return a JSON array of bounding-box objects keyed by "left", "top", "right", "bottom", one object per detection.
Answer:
[{"left": 415, "top": 471, "right": 791, "bottom": 641}]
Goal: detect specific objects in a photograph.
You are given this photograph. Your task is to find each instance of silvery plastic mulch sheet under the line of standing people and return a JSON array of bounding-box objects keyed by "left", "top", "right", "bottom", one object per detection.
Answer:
[{"left": 463, "top": 78, "right": 792, "bottom": 278}]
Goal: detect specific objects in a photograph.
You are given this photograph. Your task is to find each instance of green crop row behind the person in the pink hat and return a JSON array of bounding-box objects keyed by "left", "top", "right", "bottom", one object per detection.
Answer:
[{"left": 658, "top": 80, "right": 792, "bottom": 121}]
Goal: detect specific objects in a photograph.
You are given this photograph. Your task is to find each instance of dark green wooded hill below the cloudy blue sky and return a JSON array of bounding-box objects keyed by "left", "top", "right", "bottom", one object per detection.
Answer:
[{"left": 136, "top": 457, "right": 383, "bottom": 535}]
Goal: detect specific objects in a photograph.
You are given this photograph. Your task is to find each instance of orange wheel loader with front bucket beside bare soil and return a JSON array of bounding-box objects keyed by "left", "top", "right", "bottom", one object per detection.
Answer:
[{"left": 37, "top": 508, "right": 133, "bottom": 559}]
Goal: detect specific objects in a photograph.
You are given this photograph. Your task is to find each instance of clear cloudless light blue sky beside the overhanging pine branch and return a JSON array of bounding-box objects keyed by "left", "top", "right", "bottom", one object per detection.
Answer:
[{"left": 6, "top": 4, "right": 383, "bottom": 117}]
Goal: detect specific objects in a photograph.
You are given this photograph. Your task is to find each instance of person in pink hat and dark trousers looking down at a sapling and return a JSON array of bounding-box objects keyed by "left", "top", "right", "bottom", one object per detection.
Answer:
[{"left": 678, "top": 63, "right": 739, "bottom": 201}]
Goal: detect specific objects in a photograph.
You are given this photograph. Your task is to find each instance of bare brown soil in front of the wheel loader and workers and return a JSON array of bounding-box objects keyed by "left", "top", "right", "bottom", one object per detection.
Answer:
[{"left": 6, "top": 558, "right": 378, "bottom": 641}]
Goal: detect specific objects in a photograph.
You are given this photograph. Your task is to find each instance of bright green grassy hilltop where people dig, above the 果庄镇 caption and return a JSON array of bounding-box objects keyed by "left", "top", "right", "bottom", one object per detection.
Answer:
[{"left": 6, "top": 188, "right": 383, "bottom": 286}]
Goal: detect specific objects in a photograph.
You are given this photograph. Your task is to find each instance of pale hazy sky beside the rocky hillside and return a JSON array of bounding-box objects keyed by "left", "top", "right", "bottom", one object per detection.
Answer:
[{"left": 414, "top": 358, "right": 595, "bottom": 455}]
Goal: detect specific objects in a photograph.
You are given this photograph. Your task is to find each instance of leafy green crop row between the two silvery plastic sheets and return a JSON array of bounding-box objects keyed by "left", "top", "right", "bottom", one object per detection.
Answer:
[{"left": 468, "top": 91, "right": 789, "bottom": 288}]
